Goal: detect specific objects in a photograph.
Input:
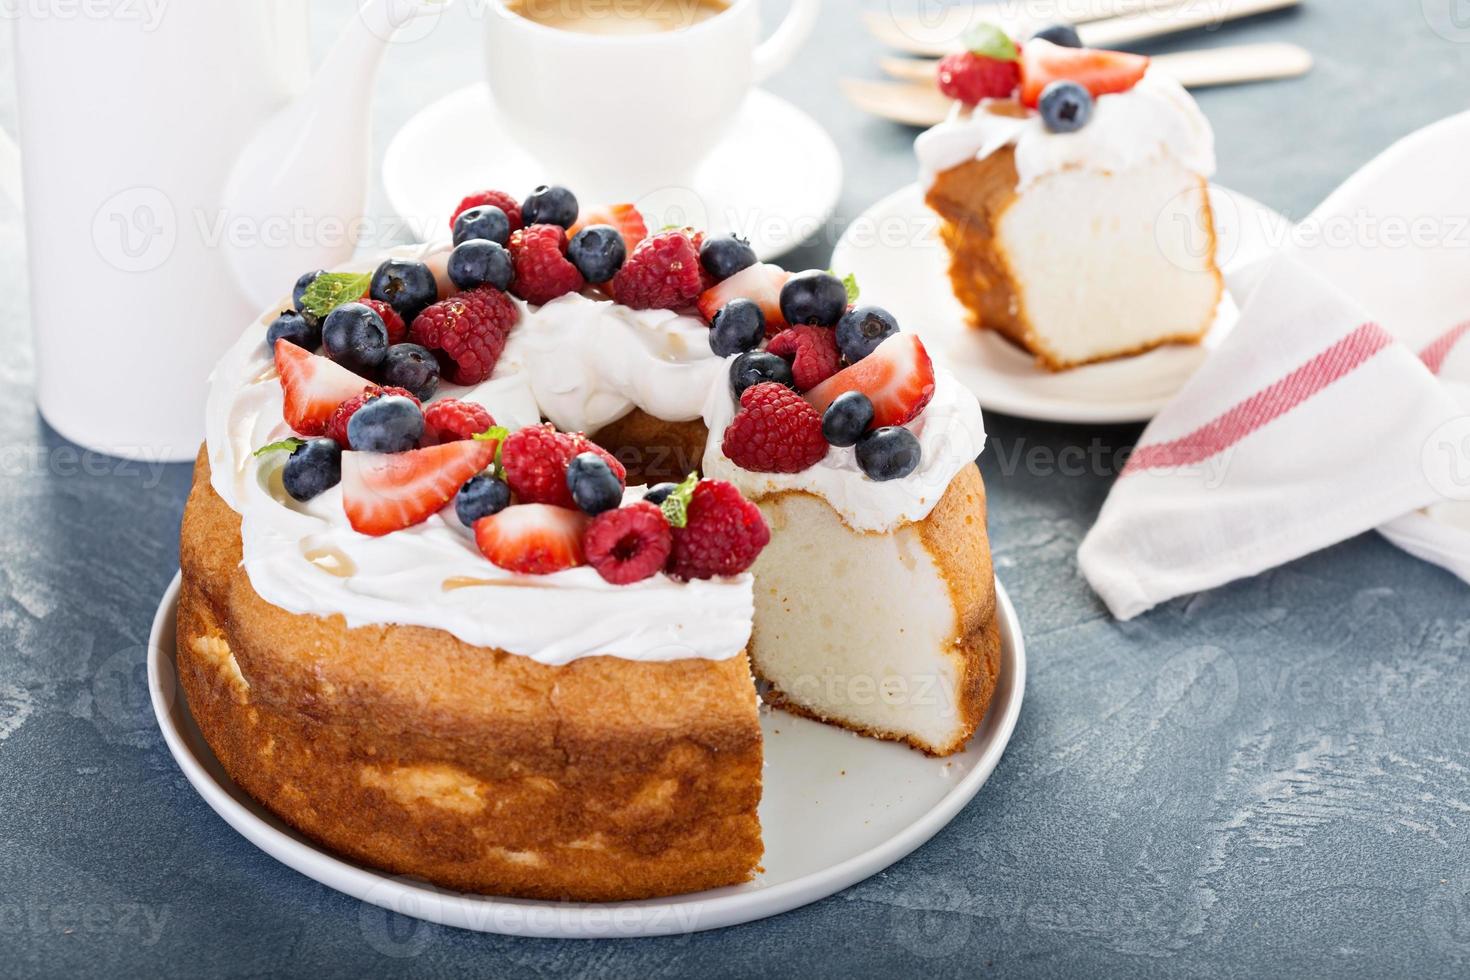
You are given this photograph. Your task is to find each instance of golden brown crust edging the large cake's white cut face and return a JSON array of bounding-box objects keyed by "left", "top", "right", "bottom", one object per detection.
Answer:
[{"left": 753, "top": 466, "right": 1001, "bottom": 755}]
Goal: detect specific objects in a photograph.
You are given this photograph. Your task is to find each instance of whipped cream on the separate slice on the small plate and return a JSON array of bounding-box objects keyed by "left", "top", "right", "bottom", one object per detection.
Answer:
[{"left": 914, "top": 61, "right": 1216, "bottom": 190}]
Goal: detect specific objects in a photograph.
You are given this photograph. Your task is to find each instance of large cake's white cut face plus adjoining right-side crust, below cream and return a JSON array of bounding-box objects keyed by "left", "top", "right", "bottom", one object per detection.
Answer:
[{"left": 750, "top": 466, "right": 1000, "bottom": 755}]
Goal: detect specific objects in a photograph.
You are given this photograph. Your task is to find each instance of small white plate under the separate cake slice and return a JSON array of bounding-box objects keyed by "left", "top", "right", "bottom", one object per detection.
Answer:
[{"left": 832, "top": 184, "right": 1291, "bottom": 425}]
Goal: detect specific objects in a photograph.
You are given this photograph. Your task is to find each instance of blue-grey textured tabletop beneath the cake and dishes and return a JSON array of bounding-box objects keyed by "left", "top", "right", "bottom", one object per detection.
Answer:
[{"left": 0, "top": 0, "right": 1470, "bottom": 977}]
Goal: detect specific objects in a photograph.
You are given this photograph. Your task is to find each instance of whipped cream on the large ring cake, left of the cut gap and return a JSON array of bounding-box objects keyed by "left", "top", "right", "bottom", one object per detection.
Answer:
[{"left": 206, "top": 251, "right": 754, "bottom": 666}]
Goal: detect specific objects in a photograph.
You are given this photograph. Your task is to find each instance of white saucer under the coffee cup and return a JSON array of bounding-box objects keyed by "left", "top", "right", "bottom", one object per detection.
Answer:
[{"left": 382, "top": 85, "right": 842, "bottom": 262}]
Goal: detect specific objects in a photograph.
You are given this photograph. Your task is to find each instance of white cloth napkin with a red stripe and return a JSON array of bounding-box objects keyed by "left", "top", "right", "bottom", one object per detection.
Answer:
[{"left": 1078, "top": 113, "right": 1470, "bottom": 619}]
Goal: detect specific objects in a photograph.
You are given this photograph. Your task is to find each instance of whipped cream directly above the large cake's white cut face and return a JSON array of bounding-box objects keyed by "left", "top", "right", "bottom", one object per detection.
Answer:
[{"left": 704, "top": 369, "right": 985, "bottom": 532}]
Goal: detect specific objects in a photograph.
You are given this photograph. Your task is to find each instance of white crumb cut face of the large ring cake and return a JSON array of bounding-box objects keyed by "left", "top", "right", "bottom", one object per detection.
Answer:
[{"left": 751, "top": 494, "right": 963, "bottom": 751}]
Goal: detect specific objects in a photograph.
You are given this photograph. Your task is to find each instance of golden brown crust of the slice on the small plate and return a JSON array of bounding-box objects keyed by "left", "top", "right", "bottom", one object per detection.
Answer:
[{"left": 925, "top": 147, "right": 1225, "bottom": 372}]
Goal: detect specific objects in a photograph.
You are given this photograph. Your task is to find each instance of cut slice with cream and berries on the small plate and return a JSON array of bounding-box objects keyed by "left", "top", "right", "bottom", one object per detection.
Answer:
[{"left": 916, "top": 28, "right": 1223, "bottom": 370}]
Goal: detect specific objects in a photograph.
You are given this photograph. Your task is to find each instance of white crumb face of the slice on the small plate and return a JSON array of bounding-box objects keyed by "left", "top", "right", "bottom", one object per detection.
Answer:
[{"left": 997, "top": 157, "right": 1220, "bottom": 364}]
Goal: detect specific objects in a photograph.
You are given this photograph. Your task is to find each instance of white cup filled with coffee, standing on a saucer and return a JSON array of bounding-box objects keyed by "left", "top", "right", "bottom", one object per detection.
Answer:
[{"left": 485, "top": 0, "right": 820, "bottom": 203}]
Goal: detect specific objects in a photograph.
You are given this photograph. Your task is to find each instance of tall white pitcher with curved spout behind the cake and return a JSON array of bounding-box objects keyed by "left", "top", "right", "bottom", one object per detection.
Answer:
[{"left": 0, "top": 0, "right": 445, "bottom": 460}]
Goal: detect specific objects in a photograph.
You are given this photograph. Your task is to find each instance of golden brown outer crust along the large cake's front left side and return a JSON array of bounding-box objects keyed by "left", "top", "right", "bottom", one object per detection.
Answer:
[{"left": 178, "top": 453, "right": 761, "bottom": 901}]
